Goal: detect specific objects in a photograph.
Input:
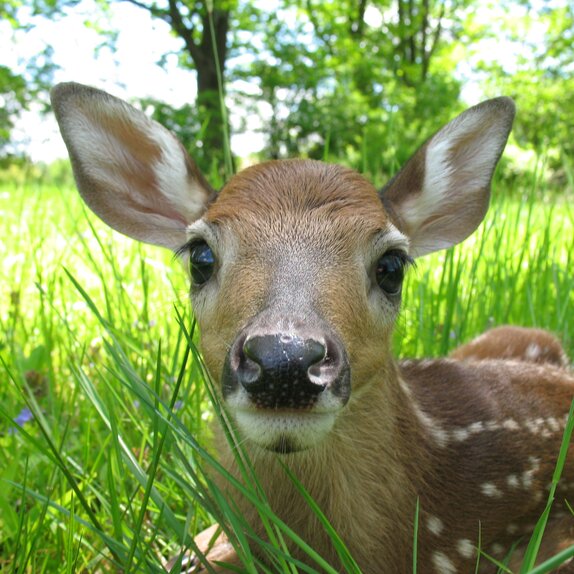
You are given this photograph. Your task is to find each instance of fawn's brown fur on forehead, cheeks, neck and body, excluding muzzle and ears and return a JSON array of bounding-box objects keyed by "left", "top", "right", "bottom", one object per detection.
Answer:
[{"left": 187, "top": 161, "right": 574, "bottom": 574}]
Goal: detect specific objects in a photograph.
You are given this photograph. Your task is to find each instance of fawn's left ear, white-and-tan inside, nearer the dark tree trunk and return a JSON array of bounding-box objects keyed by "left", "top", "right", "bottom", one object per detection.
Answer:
[{"left": 51, "top": 83, "right": 215, "bottom": 249}]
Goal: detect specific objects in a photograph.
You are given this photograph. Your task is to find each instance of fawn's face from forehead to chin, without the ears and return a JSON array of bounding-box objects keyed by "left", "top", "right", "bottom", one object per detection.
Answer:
[{"left": 186, "top": 161, "right": 409, "bottom": 452}]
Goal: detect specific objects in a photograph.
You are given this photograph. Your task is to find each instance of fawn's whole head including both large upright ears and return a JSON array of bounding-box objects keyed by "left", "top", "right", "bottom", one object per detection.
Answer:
[{"left": 52, "top": 84, "right": 514, "bottom": 452}]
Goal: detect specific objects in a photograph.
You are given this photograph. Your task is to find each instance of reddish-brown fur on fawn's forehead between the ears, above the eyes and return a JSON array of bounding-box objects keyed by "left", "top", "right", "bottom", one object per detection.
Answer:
[{"left": 205, "top": 160, "right": 388, "bottom": 244}]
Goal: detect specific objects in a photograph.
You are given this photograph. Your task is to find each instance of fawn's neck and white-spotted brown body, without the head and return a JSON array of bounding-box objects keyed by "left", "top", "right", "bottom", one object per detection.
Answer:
[{"left": 215, "top": 348, "right": 574, "bottom": 574}]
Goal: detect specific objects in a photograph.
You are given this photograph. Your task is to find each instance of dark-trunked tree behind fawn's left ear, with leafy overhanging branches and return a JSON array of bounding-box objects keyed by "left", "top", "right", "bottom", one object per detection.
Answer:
[{"left": 0, "top": 0, "right": 238, "bottom": 172}]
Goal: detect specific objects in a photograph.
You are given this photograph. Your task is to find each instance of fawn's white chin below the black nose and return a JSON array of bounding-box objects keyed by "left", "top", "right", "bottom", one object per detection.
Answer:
[{"left": 234, "top": 410, "right": 336, "bottom": 454}]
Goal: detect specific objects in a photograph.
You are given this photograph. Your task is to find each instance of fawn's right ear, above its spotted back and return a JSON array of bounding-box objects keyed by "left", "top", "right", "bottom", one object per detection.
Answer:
[{"left": 381, "top": 98, "right": 515, "bottom": 257}]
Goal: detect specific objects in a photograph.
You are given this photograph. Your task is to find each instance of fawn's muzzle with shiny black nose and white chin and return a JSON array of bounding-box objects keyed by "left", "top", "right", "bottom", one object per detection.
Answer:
[{"left": 222, "top": 317, "right": 351, "bottom": 453}]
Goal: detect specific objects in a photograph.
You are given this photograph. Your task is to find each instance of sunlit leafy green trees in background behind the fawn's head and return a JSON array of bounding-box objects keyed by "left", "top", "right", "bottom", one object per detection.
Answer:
[{"left": 0, "top": 0, "right": 574, "bottom": 189}]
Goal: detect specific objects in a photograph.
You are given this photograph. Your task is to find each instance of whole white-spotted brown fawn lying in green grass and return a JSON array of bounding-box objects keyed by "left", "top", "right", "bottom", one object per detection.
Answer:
[{"left": 52, "top": 84, "right": 574, "bottom": 574}]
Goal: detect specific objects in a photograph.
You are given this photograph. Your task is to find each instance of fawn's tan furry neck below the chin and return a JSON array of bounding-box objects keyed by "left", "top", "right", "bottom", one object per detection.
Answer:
[{"left": 216, "top": 362, "right": 427, "bottom": 566}]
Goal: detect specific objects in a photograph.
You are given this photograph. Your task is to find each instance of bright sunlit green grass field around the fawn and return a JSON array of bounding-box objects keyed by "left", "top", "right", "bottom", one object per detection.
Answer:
[{"left": 0, "top": 170, "right": 574, "bottom": 573}]
